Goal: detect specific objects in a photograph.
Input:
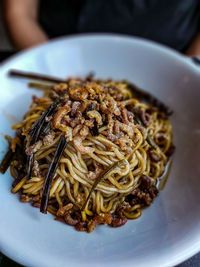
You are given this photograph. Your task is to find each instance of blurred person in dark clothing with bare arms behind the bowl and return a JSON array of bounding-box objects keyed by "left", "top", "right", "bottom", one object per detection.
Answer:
[{"left": 4, "top": 0, "right": 200, "bottom": 56}]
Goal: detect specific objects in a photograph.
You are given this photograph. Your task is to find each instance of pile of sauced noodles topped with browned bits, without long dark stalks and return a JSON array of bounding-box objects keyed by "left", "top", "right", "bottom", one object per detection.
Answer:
[{"left": 5, "top": 79, "right": 173, "bottom": 232}]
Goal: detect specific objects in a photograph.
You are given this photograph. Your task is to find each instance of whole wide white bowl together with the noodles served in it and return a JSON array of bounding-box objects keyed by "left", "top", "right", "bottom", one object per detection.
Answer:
[{"left": 0, "top": 34, "right": 200, "bottom": 266}]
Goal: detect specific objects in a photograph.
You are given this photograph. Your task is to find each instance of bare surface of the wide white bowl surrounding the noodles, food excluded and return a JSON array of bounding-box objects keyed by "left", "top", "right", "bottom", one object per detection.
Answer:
[{"left": 0, "top": 35, "right": 200, "bottom": 267}]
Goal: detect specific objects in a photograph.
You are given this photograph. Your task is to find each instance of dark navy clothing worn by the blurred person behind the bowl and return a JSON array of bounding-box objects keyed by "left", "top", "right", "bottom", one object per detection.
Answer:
[{"left": 40, "top": 0, "right": 200, "bottom": 51}]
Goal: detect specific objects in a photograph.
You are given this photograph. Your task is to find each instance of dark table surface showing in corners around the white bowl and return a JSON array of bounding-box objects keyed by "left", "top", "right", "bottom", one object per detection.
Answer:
[{"left": 0, "top": 51, "right": 200, "bottom": 267}]
